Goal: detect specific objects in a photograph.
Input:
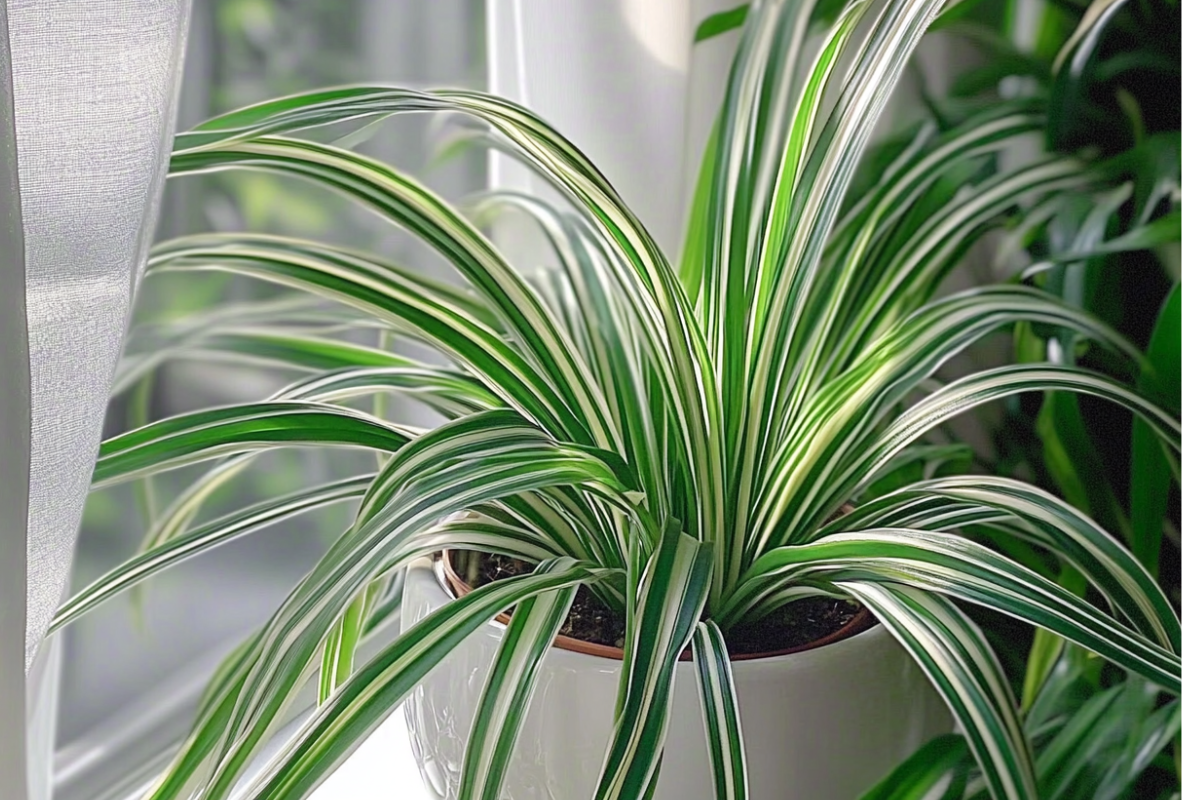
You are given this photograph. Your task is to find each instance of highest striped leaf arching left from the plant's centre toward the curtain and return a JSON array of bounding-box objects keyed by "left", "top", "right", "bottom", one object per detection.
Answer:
[{"left": 176, "top": 86, "right": 725, "bottom": 575}]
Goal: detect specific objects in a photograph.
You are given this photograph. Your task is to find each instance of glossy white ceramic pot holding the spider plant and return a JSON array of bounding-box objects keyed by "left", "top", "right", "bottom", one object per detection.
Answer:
[{"left": 401, "top": 560, "right": 952, "bottom": 800}]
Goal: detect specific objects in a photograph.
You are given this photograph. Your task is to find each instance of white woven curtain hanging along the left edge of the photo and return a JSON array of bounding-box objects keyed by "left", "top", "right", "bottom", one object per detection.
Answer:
[{"left": 0, "top": 0, "right": 190, "bottom": 800}]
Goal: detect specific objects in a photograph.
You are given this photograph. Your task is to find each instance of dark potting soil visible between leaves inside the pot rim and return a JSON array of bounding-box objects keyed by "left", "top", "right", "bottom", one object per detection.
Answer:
[{"left": 454, "top": 552, "right": 859, "bottom": 656}]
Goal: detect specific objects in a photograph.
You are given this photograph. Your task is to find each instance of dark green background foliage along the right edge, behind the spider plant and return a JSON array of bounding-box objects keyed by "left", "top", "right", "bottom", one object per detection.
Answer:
[{"left": 872, "top": 2, "right": 1182, "bottom": 799}]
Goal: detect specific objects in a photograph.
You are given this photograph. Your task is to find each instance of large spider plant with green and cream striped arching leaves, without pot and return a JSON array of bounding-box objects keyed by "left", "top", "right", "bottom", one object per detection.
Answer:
[{"left": 56, "top": 0, "right": 1181, "bottom": 800}]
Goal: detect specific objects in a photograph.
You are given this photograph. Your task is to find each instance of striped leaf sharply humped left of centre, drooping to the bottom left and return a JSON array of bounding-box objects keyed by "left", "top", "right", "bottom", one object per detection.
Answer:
[{"left": 155, "top": 411, "right": 638, "bottom": 800}]
